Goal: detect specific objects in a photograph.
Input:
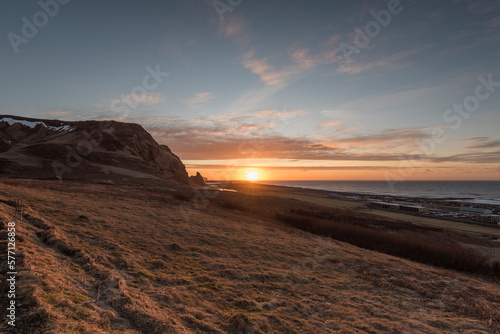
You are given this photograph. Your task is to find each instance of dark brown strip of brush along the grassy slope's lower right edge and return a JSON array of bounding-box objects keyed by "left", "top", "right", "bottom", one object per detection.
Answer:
[{"left": 275, "top": 210, "right": 500, "bottom": 277}]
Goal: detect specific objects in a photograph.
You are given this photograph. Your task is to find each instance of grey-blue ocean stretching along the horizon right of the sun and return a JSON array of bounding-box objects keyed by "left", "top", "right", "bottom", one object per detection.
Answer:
[{"left": 259, "top": 181, "right": 500, "bottom": 205}]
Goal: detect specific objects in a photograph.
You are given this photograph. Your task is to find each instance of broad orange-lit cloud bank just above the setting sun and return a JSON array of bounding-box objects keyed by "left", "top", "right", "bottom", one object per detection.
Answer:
[{"left": 82, "top": 111, "right": 500, "bottom": 169}]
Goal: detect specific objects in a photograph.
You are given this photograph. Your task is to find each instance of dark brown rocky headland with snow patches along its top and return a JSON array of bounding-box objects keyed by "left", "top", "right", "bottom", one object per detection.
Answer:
[{"left": 0, "top": 115, "right": 189, "bottom": 184}]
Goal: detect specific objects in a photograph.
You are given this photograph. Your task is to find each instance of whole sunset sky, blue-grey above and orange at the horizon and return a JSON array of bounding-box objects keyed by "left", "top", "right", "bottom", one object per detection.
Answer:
[{"left": 0, "top": 0, "right": 500, "bottom": 181}]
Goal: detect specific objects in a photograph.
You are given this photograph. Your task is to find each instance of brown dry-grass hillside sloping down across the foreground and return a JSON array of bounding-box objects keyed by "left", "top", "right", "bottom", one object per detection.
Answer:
[{"left": 0, "top": 180, "right": 500, "bottom": 333}]
